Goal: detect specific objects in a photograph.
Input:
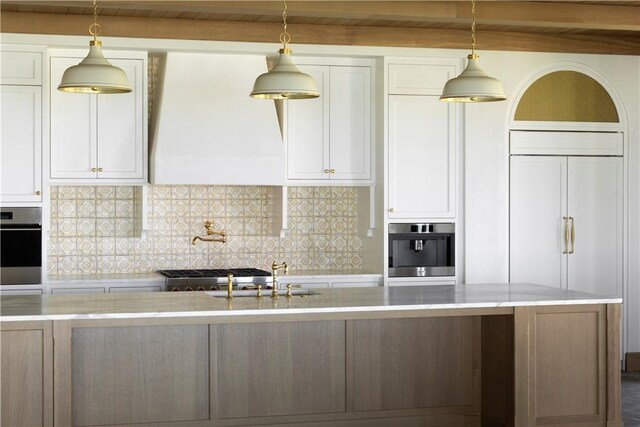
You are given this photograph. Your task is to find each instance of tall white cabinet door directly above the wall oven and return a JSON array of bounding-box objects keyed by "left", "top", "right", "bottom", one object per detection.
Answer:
[{"left": 0, "top": 85, "right": 42, "bottom": 202}]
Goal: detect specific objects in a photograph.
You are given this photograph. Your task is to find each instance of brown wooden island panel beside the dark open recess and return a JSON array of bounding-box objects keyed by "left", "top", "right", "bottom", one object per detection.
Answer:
[{"left": 348, "top": 316, "right": 480, "bottom": 416}]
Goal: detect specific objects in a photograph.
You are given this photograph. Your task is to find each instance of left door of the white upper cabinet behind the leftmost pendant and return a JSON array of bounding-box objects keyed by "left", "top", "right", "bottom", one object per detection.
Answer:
[{"left": 50, "top": 58, "right": 95, "bottom": 179}]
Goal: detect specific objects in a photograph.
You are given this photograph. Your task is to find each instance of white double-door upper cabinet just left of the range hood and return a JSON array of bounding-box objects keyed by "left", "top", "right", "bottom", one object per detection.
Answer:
[{"left": 50, "top": 52, "right": 147, "bottom": 184}]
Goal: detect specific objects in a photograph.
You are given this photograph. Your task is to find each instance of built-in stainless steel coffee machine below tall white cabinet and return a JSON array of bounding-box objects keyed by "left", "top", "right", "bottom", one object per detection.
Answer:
[{"left": 389, "top": 223, "right": 456, "bottom": 277}]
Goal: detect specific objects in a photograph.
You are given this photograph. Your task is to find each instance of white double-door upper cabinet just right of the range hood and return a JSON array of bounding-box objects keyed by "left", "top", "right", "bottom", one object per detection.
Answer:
[{"left": 286, "top": 61, "right": 371, "bottom": 185}]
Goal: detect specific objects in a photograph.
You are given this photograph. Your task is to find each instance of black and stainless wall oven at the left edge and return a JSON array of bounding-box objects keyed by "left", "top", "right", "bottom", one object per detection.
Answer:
[{"left": 0, "top": 208, "right": 42, "bottom": 285}]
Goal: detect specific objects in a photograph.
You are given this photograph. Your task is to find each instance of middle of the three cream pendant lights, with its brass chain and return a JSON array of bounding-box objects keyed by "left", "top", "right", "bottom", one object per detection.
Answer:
[{"left": 251, "top": 2, "right": 320, "bottom": 99}]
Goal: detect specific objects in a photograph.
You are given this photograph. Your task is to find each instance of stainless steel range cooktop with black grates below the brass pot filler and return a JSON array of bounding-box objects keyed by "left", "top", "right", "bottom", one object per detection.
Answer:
[{"left": 158, "top": 268, "right": 271, "bottom": 292}]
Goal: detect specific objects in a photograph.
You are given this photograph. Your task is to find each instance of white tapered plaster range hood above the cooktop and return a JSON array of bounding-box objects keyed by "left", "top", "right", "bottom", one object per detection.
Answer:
[{"left": 149, "top": 52, "right": 285, "bottom": 186}]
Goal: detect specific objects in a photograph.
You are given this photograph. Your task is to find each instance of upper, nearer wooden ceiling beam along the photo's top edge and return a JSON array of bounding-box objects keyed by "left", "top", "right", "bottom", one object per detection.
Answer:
[{"left": 3, "top": 0, "right": 640, "bottom": 32}]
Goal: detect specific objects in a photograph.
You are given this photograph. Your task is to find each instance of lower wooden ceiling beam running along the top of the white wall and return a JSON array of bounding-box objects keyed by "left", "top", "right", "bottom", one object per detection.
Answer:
[{"left": 0, "top": 12, "right": 640, "bottom": 55}]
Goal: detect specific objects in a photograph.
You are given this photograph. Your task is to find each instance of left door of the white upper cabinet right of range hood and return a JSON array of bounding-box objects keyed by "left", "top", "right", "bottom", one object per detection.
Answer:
[{"left": 286, "top": 65, "right": 330, "bottom": 180}]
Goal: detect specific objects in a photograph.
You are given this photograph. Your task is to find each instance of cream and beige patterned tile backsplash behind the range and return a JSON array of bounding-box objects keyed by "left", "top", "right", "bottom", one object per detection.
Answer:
[{"left": 48, "top": 185, "right": 362, "bottom": 275}]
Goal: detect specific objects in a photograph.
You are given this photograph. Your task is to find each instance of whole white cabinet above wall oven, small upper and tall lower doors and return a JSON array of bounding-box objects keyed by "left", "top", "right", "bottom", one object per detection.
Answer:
[{"left": 0, "top": 45, "right": 44, "bottom": 204}]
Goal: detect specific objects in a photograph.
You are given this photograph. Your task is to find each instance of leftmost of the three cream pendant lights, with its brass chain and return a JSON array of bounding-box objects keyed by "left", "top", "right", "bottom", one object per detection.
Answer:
[{"left": 58, "top": 0, "right": 131, "bottom": 93}]
